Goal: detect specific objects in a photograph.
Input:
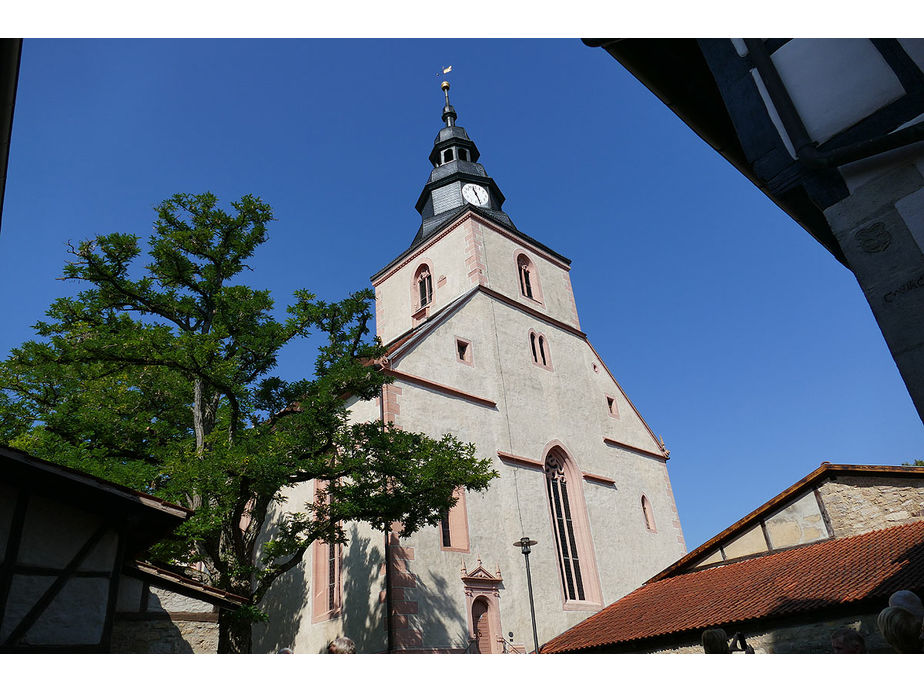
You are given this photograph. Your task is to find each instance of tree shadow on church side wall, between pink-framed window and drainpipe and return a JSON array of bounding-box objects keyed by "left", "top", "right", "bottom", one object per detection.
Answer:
[{"left": 341, "top": 525, "right": 386, "bottom": 653}]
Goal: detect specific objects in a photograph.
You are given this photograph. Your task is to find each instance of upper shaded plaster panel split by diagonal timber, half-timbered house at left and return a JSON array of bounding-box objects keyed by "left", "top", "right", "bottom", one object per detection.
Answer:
[{"left": 19, "top": 496, "right": 118, "bottom": 570}]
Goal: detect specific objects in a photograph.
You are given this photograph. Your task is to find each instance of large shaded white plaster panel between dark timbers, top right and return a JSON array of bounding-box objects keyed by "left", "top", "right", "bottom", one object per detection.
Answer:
[{"left": 771, "top": 39, "right": 905, "bottom": 143}]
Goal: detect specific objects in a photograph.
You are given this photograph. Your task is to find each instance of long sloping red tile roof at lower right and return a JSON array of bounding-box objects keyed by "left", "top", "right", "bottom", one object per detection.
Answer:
[{"left": 541, "top": 522, "right": 924, "bottom": 653}]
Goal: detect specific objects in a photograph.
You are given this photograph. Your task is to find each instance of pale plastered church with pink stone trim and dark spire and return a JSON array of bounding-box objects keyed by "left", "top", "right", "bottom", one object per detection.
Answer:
[{"left": 254, "top": 82, "right": 686, "bottom": 654}]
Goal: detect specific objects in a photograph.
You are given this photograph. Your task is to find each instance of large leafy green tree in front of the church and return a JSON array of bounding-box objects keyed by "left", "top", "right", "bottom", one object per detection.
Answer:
[{"left": 0, "top": 193, "right": 496, "bottom": 652}]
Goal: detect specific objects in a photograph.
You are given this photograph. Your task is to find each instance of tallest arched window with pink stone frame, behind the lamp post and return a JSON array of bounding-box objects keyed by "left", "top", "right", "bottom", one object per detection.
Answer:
[{"left": 545, "top": 448, "right": 599, "bottom": 601}]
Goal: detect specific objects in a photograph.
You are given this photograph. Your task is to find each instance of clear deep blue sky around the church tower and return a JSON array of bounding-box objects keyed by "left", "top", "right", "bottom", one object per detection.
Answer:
[{"left": 0, "top": 39, "right": 924, "bottom": 549}]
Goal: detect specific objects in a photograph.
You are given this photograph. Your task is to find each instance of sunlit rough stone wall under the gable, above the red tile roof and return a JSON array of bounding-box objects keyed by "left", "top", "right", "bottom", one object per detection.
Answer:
[{"left": 819, "top": 476, "right": 924, "bottom": 538}]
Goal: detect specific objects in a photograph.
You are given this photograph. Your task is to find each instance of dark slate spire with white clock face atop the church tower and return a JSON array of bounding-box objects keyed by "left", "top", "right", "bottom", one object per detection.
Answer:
[{"left": 411, "top": 82, "right": 516, "bottom": 247}]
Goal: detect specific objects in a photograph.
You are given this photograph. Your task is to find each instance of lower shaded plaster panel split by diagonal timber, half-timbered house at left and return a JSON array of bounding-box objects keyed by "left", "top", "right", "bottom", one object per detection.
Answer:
[{"left": 0, "top": 575, "right": 109, "bottom": 645}]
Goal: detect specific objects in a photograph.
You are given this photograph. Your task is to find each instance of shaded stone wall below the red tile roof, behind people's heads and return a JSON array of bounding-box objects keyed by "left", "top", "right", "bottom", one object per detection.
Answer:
[{"left": 639, "top": 604, "right": 892, "bottom": 654}]
